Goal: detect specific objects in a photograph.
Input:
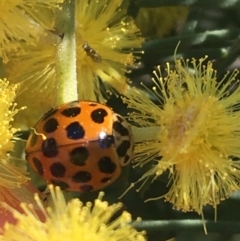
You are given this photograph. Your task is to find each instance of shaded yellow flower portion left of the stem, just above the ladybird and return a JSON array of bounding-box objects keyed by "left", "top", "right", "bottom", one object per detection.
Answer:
[{"left": 6, "top": 43, "right": 57, "bottom": 129}]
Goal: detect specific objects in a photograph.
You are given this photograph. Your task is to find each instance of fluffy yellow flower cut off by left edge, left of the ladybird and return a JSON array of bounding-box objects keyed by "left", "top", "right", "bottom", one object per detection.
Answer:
[{"left": 0, "top": 79, "right": 27, "bottom": 200}]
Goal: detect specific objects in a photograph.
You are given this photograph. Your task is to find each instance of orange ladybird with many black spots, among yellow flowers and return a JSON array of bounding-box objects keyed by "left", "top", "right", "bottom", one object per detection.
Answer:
[{"left": 26, "top": 101, "right": 134, "bottom": 192}]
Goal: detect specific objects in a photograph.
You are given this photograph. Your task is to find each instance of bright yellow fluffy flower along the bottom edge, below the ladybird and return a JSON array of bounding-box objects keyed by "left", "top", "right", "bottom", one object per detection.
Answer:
[{"left": 2, "top": 185, "right": 145, "bottom": 241}]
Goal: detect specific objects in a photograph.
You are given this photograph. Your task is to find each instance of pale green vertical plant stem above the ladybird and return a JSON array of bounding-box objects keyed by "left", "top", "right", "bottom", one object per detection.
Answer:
[{"left": 56, "top": 0, "right": 78, "bottom": 104}]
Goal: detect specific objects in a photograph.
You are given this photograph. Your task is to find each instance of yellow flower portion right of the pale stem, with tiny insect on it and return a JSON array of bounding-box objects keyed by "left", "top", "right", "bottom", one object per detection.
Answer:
[{"left": 76, "top": 0, "right": 143, "bottom": 100}]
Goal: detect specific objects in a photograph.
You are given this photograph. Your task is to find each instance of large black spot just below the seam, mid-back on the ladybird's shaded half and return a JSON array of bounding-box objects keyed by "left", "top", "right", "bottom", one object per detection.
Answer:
[{"left": 70, "top": 146, "right": 89, "bottom": 166}]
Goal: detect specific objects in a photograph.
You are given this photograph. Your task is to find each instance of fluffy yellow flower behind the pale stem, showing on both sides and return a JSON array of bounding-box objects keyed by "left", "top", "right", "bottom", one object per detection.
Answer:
[{"left": 6, "top": 0, "right": 143, "bottom": 128}]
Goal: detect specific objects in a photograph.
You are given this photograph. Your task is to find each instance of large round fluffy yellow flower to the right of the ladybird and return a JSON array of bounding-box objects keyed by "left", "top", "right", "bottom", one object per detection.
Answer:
[{"left": 125, "top": 58, "right": 240, "bottom": 217}]
